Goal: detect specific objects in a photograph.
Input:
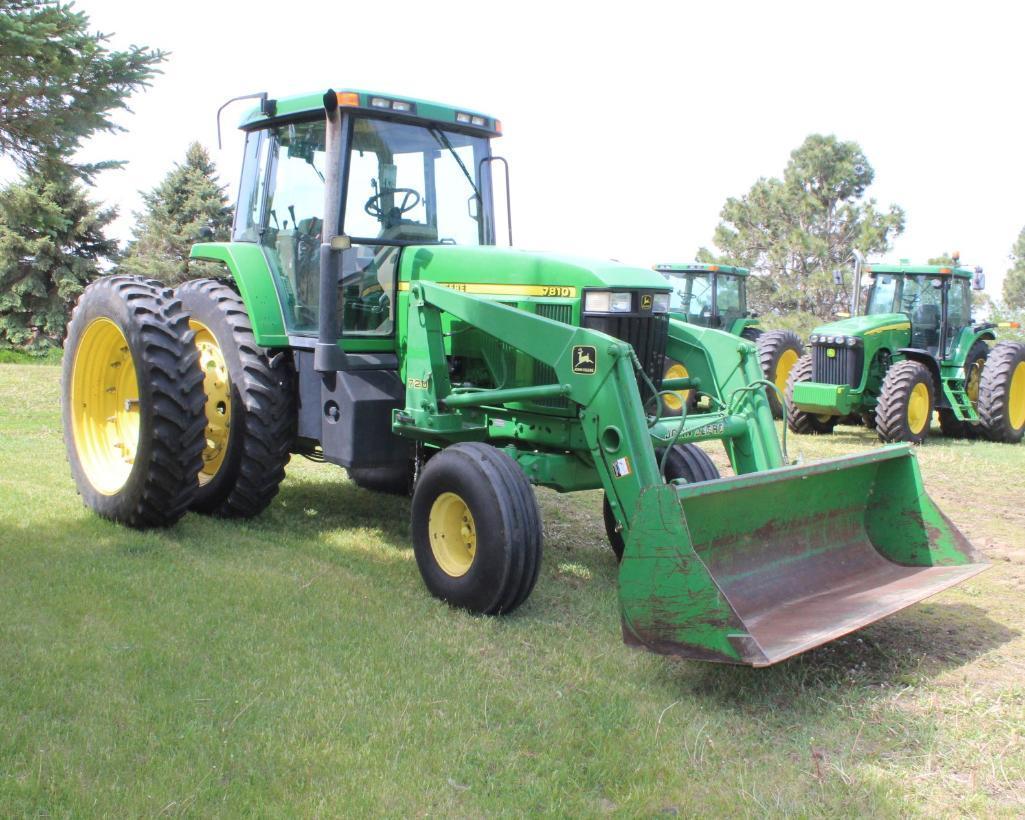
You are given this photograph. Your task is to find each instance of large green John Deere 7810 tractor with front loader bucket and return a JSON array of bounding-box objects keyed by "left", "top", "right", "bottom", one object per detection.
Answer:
[{"left": 63, "top": 90, "right": 986, "bottom": 666}]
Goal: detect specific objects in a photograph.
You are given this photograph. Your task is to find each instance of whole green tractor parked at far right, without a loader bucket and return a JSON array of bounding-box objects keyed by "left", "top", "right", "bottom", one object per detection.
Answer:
[{"left": 787, "top": 256, "right": 1025, "bottom": 444}]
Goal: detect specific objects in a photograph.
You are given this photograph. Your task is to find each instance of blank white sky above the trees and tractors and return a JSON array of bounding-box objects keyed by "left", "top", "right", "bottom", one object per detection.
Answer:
[{"left": 66, "top": 0, "right": 1025, "bottom": 294}]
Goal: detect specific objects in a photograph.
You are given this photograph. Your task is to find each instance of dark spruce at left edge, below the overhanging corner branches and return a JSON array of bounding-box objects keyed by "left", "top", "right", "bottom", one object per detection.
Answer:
[{"left": 0, "top": 164, "right": 117, "bottom": 351}]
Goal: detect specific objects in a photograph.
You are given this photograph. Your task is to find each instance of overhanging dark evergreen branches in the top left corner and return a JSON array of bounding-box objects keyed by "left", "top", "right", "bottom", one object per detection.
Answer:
[{"left": 0, "top": 0, "right": 165, "bottom": 178}]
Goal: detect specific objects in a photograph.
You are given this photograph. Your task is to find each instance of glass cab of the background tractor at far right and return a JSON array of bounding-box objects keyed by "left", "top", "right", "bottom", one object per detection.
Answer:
[{"left": 865, "top": 265, "right": 973, "bottom": 360}]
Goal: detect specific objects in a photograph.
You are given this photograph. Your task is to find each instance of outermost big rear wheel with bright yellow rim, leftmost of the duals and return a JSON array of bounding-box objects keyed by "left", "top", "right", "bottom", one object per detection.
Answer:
[{"left": 62, "top": 276, "right": 203, "bottom": 527}]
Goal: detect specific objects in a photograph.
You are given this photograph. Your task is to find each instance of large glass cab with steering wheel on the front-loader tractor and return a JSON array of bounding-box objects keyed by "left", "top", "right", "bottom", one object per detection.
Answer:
[{"left": 234, "top": 91, "right": 501, "bottom": 346}]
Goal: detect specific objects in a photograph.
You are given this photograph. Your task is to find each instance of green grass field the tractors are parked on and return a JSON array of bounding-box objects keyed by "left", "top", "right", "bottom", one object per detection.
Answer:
[{"left": 0, "top": 365, "right": 1025, "bottom": 816}]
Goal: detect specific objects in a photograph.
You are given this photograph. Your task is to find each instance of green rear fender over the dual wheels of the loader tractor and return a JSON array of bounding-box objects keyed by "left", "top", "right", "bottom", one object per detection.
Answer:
[{"left": 189, "top": 242, "right": 288, "bottom": 347}]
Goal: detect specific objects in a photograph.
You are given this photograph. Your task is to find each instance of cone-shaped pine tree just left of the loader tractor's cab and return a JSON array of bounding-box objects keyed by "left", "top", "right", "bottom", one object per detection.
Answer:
[{"left": 120, "top": 142, "right": 232, "bottom": 285}]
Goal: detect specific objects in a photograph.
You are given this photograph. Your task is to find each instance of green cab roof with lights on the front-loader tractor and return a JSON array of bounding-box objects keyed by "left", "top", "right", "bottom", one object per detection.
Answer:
[{"left": 239, "top": 88, "right": 502, "bottom": 136}]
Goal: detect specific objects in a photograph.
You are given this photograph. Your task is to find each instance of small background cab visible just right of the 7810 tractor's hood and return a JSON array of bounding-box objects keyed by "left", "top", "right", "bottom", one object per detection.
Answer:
[{"left": 655, "top": 262, "right": 754, "bottom": 335}]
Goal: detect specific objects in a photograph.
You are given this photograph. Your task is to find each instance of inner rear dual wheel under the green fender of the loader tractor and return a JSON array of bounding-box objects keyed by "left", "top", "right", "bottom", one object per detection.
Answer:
[{"left": 176, "top": 279, "right": 295, "bottom": 518}]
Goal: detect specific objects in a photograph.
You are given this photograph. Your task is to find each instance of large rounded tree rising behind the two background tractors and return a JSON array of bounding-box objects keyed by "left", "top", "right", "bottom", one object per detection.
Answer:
[{"left": 700, "top": 134, "right": 904, "bottom": 319}]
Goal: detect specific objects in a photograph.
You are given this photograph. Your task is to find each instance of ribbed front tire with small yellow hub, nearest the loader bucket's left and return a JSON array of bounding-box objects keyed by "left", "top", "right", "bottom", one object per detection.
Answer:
[{"left": 412, "top": 442, "right": 543, "bottom": 615}]
